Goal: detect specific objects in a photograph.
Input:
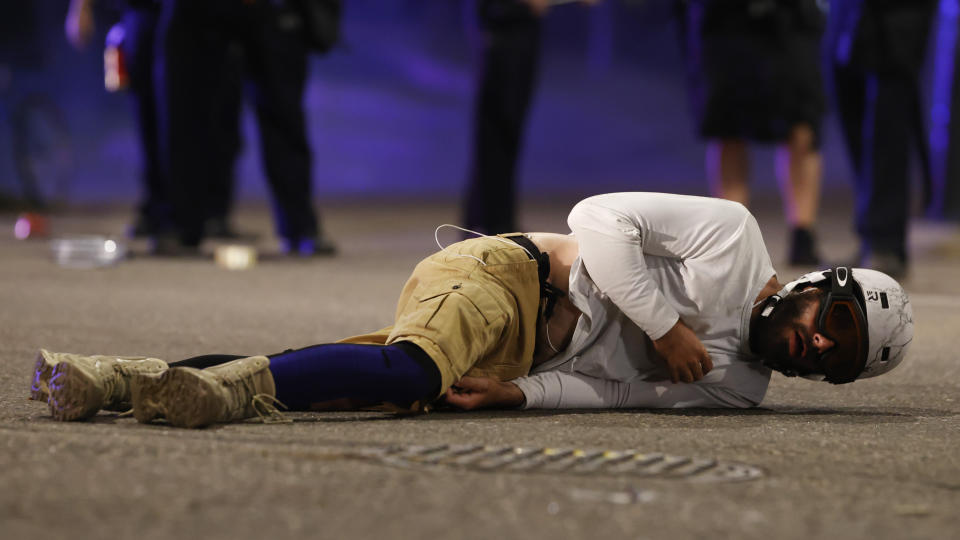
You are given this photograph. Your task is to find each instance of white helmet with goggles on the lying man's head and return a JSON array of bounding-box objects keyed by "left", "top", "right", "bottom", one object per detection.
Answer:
[{"left": 760, "top": 266, "right": 913, "bottom": 384}]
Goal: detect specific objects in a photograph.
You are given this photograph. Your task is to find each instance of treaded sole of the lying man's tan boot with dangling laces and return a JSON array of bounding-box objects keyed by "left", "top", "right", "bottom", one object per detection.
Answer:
[{"left": 133, "top": 368, "right": 224, "bottom": 428}]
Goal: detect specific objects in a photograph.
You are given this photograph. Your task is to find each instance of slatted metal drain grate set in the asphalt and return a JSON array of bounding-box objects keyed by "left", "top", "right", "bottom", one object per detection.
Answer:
[{"left": 358, "top": 444, "right": 764, "bottom": 482}]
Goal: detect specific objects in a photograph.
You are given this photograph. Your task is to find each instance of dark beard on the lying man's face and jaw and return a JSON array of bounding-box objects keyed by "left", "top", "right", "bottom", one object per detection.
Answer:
[{"left": 750, "top": 291, "right": 818, "bottom": 375}]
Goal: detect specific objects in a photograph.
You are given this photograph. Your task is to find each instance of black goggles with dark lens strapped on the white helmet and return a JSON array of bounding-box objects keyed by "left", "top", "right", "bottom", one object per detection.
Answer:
[{"left": 816, "top": 266, "right": 869, "bottom": 384}]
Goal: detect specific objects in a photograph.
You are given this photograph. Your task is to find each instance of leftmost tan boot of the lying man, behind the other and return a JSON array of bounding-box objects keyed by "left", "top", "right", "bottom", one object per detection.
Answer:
[{"left": 42, "top": 349, "right": 167, "bottom": 421}]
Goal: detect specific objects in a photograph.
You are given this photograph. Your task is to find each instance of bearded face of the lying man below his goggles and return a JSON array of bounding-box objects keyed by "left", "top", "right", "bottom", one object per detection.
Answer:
[{"left": 757, "top": 288, "right": 834, "bottom": 375}]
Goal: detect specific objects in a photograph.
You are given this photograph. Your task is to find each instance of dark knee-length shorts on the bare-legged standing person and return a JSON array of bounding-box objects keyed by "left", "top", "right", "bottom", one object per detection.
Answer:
[{"left": 682, "top": 0, "right": 826, "bottom": 144}]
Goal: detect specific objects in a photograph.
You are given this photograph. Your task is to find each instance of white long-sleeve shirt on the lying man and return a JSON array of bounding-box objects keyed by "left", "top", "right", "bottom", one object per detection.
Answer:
[{"left": 512, "top": 193, "right": 775, "bottom": 408}]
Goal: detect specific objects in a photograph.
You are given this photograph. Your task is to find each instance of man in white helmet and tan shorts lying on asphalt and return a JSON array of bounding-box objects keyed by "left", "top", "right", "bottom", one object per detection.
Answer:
[{"left": 31, "top": 193, "right": 913, "bottom": 427}]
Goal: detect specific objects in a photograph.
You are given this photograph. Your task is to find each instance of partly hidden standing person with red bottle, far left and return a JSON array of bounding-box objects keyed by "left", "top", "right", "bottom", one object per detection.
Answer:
[{"left": 64, "top": 0, "right": 240, "bottom": 237}]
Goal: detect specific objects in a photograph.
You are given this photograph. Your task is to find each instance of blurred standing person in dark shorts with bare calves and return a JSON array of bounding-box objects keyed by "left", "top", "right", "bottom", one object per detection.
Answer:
[{"left": 678, "top": 0, "right": 825, "bottom": 265}]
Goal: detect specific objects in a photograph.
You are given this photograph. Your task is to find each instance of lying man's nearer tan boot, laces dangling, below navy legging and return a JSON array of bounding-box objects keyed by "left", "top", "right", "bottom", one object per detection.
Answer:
[{"left": 132, "top": 356, "right": 282, "bottom": 428}]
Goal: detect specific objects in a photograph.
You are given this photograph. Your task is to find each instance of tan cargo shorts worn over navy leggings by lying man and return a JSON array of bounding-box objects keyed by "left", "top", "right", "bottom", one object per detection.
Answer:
[{"left": 342, "top": 235, "right": 540, "bottom": 397}]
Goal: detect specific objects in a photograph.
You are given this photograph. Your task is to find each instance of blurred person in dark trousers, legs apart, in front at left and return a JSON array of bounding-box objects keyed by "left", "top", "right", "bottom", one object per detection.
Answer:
[{"left": 155, "top": 0, "right": 339, "bottom": 256}]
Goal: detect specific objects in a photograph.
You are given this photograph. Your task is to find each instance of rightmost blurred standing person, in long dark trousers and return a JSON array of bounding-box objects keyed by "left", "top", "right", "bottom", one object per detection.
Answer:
[{"left": 828, "top": 0, "right": 936, "bottom": 278}]
